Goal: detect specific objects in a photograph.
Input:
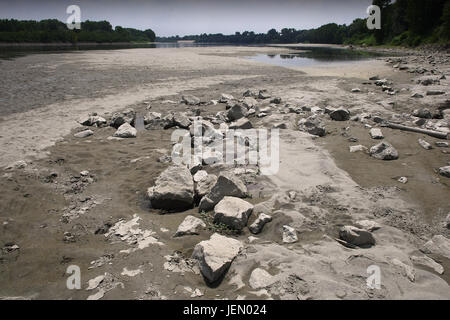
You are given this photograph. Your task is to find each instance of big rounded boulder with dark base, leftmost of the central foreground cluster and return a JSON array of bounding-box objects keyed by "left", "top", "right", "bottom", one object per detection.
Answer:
[{"left": 148, "top": 166, "right": 194, "bottom": 211}]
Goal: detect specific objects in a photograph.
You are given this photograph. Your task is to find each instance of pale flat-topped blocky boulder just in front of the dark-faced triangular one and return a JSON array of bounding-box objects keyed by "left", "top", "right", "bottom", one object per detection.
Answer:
[{"left": 214, "top": 197, "right": 253, "bottom": 231}]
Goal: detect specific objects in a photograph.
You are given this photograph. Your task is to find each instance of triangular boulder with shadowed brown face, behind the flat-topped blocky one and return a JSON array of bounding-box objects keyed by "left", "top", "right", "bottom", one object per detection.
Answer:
[{"left": 198, "top": 173, "right": 247, "bottom": 211}]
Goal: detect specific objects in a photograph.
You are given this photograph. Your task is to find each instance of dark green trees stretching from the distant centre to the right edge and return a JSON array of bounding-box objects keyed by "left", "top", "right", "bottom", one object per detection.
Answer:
[{"left": 157, "top": 0, "right": 450, "bottom": 47}]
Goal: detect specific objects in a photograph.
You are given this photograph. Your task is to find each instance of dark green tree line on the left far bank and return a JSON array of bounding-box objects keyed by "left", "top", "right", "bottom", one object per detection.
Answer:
[{"left": 0, "top": 19, "right": 156, "bottom": 43}]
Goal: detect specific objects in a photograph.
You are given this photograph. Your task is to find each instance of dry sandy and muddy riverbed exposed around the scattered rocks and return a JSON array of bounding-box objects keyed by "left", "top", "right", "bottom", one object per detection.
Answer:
[{"left": 0, "top": 47, "right": 450, "bottom": 299}]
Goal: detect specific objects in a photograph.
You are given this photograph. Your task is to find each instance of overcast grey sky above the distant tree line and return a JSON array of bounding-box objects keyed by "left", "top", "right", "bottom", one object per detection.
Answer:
[{"left": 0, "top": 0, "right": 372, "bottom": 36}]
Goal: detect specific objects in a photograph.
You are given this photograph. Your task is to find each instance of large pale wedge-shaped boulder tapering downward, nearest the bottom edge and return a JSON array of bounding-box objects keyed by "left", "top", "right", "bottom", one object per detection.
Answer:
[{"left": 192, "top": 233, "right": 243, "bottom": 283}]
